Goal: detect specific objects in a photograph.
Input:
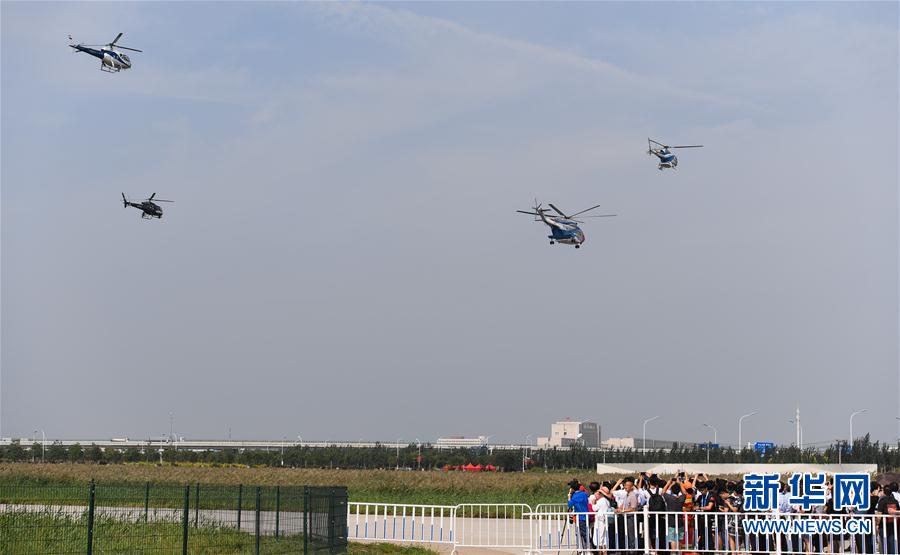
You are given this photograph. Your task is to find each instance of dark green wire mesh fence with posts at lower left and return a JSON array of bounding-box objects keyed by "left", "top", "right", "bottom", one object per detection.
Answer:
[{"left": 0, "top": 482, "right": 347, "bottom": 555}]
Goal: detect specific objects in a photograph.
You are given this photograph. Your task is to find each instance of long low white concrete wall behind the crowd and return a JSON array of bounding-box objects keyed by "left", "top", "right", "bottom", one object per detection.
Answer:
[{"left": 597, "top": 463, "right": 878, "bottom": 476}]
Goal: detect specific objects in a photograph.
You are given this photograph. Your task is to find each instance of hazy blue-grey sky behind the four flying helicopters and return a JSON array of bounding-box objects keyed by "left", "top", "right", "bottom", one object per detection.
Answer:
[{"left": 0, "top": 2, "right": 900, "bottom": 443}]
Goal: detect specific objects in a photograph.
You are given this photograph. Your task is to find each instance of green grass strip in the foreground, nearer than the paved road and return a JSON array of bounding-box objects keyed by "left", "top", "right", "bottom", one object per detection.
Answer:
[{"left": 0, "top": 512, "right": 433, "bottom": 555}]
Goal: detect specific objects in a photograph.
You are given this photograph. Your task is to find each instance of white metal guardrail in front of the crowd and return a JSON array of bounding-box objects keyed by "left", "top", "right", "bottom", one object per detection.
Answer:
[{"left": 347, "top": 503, "right": 900, "bottom": 555}]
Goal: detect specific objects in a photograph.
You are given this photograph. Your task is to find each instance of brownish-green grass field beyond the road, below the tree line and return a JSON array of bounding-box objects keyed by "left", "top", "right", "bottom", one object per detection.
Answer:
[{"left": 0, "top": 463, "right": 598, "bottom": 507}]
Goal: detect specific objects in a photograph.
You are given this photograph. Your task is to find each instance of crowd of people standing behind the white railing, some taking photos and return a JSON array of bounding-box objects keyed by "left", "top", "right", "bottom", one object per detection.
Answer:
[{"left": 567, "top": 473, "right": 900, "bottom": 555}]
